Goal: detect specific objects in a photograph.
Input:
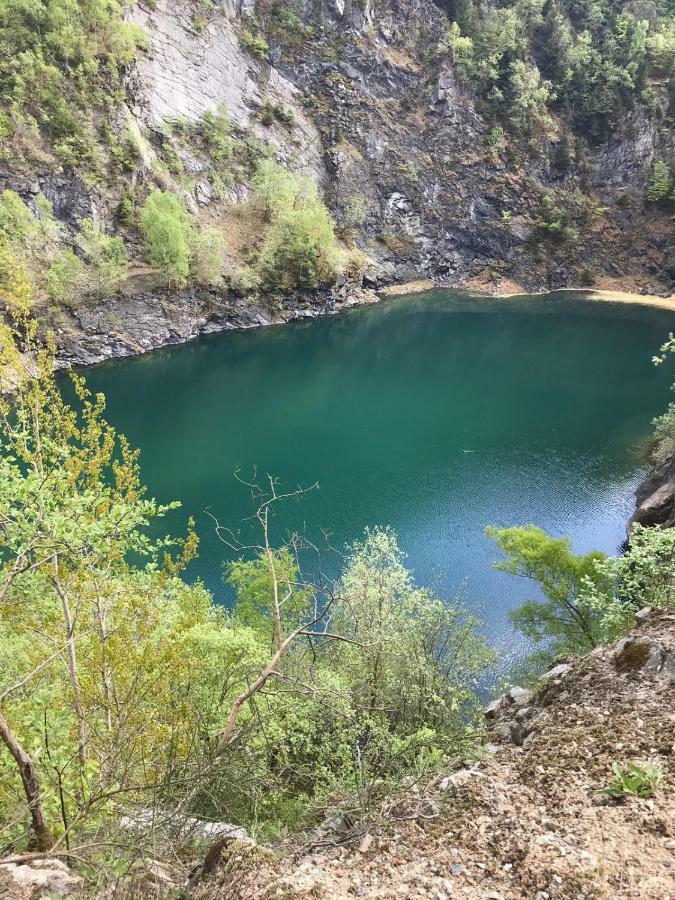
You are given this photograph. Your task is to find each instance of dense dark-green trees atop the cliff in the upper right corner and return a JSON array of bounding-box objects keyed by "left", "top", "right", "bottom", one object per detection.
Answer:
[{"left": 439, "top": 0, "right": 675, "bottom": 141}]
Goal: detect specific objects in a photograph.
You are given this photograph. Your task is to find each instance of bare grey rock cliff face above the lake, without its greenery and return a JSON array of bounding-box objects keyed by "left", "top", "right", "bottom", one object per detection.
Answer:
[{"left": 0, "top": 0, "right": 674, "bottom": 362}]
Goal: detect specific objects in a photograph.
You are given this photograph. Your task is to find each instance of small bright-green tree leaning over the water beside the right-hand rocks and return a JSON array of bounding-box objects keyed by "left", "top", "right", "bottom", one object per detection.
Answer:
[{"left": 486, "top": 525, "right": 605, "bottom": 655}]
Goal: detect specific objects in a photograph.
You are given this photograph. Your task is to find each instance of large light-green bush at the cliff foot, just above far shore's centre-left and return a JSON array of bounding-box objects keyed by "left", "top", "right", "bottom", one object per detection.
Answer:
[{"left": 254, "top": 159, "right": 340, "bottom": 290}]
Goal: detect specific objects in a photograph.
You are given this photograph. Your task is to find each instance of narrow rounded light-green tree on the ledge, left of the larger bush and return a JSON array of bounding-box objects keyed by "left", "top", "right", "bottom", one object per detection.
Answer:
[{"left": 141, "top": 191, "right": 194, "bottom": 287}]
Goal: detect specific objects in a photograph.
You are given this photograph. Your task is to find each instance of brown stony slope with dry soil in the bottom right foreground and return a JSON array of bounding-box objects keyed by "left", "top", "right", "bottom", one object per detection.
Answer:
[{"left": 188, "top": 609, "right": 675, "bottom": 900}]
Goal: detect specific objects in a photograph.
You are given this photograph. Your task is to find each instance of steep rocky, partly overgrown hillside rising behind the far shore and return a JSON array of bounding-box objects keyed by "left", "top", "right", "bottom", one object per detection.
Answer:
[{"left": 0, "top": 0, "right": 674, "bottom": 362}]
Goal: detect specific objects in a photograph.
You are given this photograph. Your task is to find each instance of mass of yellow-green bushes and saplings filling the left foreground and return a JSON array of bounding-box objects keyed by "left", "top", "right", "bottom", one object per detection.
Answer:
[{"left": 0, "top": 328, "right": 490, "bottom": 856}]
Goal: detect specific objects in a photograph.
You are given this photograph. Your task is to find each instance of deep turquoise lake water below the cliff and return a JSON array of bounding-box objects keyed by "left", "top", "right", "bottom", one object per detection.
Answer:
[{"left": 76, "top": 292, "right": 675, "bottom": 663}]
